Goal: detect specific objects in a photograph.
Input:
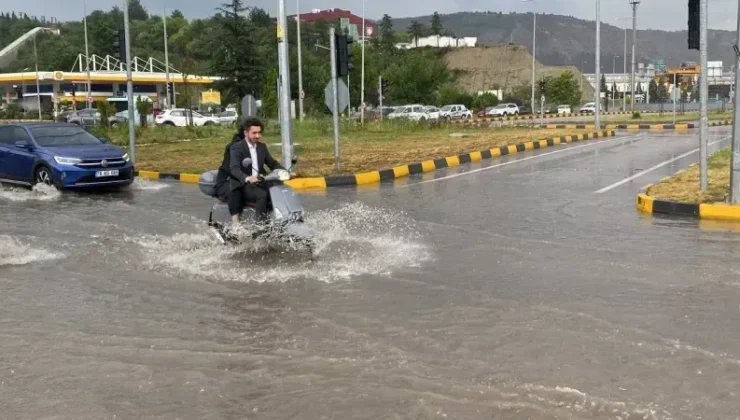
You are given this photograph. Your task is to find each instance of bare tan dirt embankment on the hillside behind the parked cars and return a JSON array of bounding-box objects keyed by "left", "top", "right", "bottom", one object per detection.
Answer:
[{"left": 445, "top": 45, "right": 594, "bottom": 100}]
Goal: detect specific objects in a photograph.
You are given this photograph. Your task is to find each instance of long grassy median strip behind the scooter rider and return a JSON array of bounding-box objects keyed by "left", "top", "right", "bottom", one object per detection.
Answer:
[{"left": 100, "top": 121, "right": 593, "bottom": 177}]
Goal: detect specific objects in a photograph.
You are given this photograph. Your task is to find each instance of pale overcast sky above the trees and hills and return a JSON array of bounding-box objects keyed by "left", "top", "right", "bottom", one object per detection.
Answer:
[{"left": 5, "top": 0, "right": 738, "bottom": 30}]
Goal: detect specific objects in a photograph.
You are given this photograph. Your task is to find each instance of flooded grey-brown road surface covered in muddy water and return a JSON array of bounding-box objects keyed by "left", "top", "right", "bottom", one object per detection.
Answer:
[{"left": 0, "top": 128, "right": 740, "bottom": 419}]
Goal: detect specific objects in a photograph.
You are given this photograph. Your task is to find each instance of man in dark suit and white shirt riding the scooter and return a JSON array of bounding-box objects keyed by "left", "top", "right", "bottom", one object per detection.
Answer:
[{"left": 216, "top": 118, "right": 295, "bottom": 236}]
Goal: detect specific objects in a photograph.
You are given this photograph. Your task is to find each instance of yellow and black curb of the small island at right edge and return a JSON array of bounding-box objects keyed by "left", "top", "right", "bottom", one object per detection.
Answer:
[{"left": 636, "top": 182, "right": 740, "bottom": 221}]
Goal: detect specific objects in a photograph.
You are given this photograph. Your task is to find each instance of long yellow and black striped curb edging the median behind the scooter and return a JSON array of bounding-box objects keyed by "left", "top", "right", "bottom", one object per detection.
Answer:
[{"left": 135, "top": 131, "right": 615, "bottom": 190}]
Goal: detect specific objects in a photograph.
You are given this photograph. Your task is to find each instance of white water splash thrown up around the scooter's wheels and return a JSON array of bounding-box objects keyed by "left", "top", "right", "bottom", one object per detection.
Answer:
[{"left": 128, "top": 203, "right": 431, "bottom": 283}]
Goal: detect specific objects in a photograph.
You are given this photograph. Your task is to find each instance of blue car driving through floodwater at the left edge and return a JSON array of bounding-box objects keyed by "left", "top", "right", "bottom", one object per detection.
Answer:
[{"left": 0, "top": 123, "right": 134, "bottom": 188}]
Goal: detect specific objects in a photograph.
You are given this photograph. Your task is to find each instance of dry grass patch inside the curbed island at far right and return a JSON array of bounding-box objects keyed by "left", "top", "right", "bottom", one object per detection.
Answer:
[{"left": 647, "top": 148, "right": 730, "bottom": 204}]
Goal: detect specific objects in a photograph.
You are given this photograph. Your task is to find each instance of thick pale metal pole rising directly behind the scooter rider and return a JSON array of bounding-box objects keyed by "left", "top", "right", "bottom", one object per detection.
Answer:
[{"left": 277, "top": 0, "right": 293, "bottom": 168}]
